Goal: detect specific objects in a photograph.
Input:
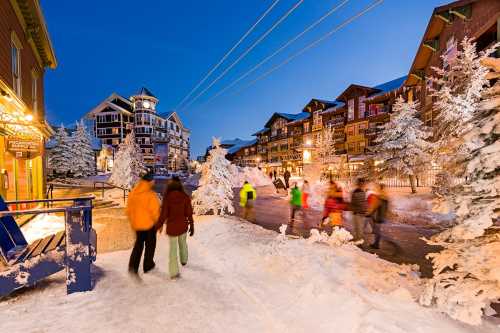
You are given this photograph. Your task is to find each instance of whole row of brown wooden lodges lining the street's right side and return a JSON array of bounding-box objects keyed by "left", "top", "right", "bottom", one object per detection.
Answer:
[{"left": 228, "top": 0, "right": 500, "bottom": 182}]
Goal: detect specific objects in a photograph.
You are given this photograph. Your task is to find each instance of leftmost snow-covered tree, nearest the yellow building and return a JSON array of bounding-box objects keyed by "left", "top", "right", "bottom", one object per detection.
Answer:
[{"left": 48, "top": 125, "right": 73, "bottom": 176}]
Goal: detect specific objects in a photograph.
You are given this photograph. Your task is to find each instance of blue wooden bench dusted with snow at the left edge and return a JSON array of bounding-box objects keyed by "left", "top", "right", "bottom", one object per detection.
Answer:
[{"left": 0, "top": 196, "right": 97, "bottom": 297}]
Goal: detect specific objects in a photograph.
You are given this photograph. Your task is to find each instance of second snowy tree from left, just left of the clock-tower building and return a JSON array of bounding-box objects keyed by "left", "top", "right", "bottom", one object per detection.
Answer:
[{"left": 71, "top": 121, "right": 96, "bottom": 178}]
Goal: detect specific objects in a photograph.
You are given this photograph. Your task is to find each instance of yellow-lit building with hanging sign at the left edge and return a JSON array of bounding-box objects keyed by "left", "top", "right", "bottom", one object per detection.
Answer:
[{"left": 0, "top": 0, "right": 57, "bottom": 200}]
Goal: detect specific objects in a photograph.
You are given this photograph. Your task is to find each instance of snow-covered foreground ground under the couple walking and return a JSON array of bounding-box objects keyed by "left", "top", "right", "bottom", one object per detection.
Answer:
[{"left": 0, "top": 217, "right": 500, "bottom": 333}]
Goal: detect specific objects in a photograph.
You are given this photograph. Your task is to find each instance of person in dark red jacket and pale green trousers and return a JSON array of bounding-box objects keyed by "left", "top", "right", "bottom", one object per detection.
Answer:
[{"left": 156, "top": 176, "right": 194, "bottom": 279}]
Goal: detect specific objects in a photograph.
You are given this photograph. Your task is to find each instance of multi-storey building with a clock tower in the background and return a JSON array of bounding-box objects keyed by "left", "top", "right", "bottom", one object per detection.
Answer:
[{"left": 85, "top": 87, "right": 191, "bottom": 174}]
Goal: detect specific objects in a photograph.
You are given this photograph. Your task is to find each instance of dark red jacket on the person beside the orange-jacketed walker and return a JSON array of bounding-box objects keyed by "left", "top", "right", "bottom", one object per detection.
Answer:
[{"left": 158, "top": 191, "right": 193, "bottom": 236}]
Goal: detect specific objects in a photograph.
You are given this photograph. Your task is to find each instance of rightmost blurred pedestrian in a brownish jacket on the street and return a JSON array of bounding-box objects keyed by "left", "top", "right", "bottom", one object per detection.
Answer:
[{"left": 366, "top": 184, "right": 389, "bottom": 249}]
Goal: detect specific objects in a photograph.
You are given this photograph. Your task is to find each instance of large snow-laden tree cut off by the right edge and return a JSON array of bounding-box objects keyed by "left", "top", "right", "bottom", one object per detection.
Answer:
[{"left": 420, "top": 58, "right": 500, "bottom": 325}]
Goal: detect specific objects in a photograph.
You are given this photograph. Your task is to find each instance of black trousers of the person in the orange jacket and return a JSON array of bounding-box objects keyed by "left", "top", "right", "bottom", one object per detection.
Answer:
[{"left": 128, "top": 227, "right": 156, "bottom": 273}]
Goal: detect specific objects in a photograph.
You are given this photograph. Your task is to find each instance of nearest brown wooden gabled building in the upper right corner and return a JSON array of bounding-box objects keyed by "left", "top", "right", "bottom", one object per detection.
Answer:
[{"left": 404, "top": 0, "right": 500, "bottom": 126}]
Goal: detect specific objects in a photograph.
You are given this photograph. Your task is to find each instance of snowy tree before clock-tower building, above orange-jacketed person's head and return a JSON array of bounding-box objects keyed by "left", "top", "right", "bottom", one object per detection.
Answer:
[{"left": 109, "top": 131, "right": 146, "bottom": 190}]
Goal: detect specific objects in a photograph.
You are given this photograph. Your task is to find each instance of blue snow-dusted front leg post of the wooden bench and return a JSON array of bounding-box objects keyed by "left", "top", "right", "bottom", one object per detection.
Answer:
[{"left": 66, "top": 199, "right": 96, "bottom": 294}]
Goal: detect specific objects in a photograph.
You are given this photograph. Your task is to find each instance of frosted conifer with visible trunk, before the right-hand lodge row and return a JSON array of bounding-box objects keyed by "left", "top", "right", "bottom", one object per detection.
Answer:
[{"left": 373, "top": 96, "right": 430, "bottom": 193}]
